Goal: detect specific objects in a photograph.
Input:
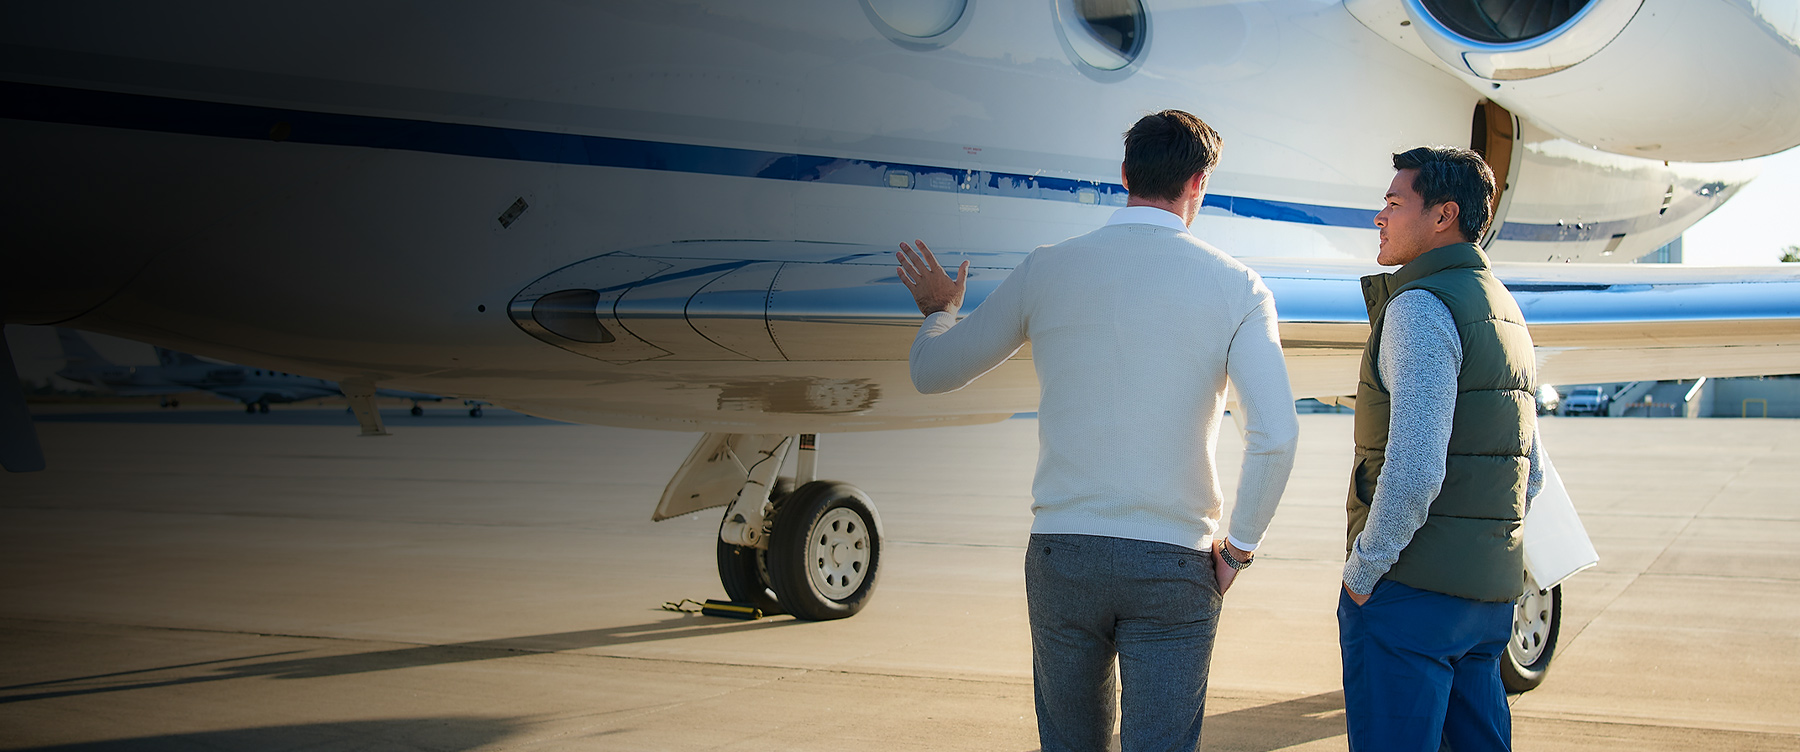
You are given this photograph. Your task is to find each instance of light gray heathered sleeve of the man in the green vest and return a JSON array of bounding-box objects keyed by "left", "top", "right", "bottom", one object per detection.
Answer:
[{"left": 1345, "top": 290, "right": 1462, "bottom": 594}]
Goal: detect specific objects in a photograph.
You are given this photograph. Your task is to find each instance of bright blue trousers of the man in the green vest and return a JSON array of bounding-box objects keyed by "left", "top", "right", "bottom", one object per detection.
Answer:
[{"left": 1337, "top": 579, "right": 1512, "bottom": 752}]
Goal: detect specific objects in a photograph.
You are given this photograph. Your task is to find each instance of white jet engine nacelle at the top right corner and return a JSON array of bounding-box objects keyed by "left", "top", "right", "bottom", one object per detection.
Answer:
[{"left": 1345, "top": 0, "right": 1800, "bottom": 162}]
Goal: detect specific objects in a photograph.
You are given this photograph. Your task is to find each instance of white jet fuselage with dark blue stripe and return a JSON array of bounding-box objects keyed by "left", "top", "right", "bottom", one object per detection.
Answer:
[{"left": 0, "top": 0, "right": 1791, "bottom": 430}]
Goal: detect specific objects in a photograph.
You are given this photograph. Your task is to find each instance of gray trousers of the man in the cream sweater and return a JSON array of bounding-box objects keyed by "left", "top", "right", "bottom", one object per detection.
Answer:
[{"left": 1024, "top": 534, "right": 1219, "bottom": 752}]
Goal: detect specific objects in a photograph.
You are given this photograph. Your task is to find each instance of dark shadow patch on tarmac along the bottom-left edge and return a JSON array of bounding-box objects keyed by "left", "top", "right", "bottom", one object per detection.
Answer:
[{"left": 7, "top": 718, "right": 524, "bottom": 752}]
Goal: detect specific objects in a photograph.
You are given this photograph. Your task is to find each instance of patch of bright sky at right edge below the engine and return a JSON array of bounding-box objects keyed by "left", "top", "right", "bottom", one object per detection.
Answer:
[{"left": 1681, "top": 148, "right": 1800, "bottom": 266}]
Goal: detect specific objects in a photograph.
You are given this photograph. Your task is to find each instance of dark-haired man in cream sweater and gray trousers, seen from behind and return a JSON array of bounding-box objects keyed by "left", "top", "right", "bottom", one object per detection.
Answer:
[{"left": 900, "top": 110, "right": 1300, "bottom": 752}]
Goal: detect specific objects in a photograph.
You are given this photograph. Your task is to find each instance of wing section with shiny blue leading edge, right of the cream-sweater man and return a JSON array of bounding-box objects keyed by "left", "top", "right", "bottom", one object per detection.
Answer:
[{"left": 1244, "top": 259, "right": 1800, "bottom": 396}]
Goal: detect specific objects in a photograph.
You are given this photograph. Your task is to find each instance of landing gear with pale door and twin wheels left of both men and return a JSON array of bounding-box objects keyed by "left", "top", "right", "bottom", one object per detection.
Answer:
[{"left": 653, "top": 434, "right": 882, "bottom": 621}]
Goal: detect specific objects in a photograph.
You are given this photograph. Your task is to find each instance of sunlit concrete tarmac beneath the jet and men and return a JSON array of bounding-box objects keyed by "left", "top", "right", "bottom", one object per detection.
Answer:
[{"left": 0, "top": 408, "right": 1800, "bottom": 750}]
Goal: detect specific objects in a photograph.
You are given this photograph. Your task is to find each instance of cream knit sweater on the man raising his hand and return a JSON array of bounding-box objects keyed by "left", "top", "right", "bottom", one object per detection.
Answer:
[{"left": 911, "top": 207, "right": 1300, "bottom": 551}]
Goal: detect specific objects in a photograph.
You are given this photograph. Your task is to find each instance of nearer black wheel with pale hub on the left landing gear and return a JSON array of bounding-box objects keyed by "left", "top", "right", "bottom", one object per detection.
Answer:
[{"left": 769, "top": 480, "right": 882, "bottom": 621}]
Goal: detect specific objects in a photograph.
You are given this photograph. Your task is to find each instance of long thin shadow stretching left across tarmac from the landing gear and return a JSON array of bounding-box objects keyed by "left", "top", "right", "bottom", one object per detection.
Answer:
[{"left": 0, "top": 615, "right": 799, "bottom": 708}]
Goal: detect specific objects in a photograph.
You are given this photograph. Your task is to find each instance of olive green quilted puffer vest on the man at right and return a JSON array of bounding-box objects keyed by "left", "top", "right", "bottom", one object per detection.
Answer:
[{"left": 1345, "top": 243, "right": 1537, "bottom": 601}]
